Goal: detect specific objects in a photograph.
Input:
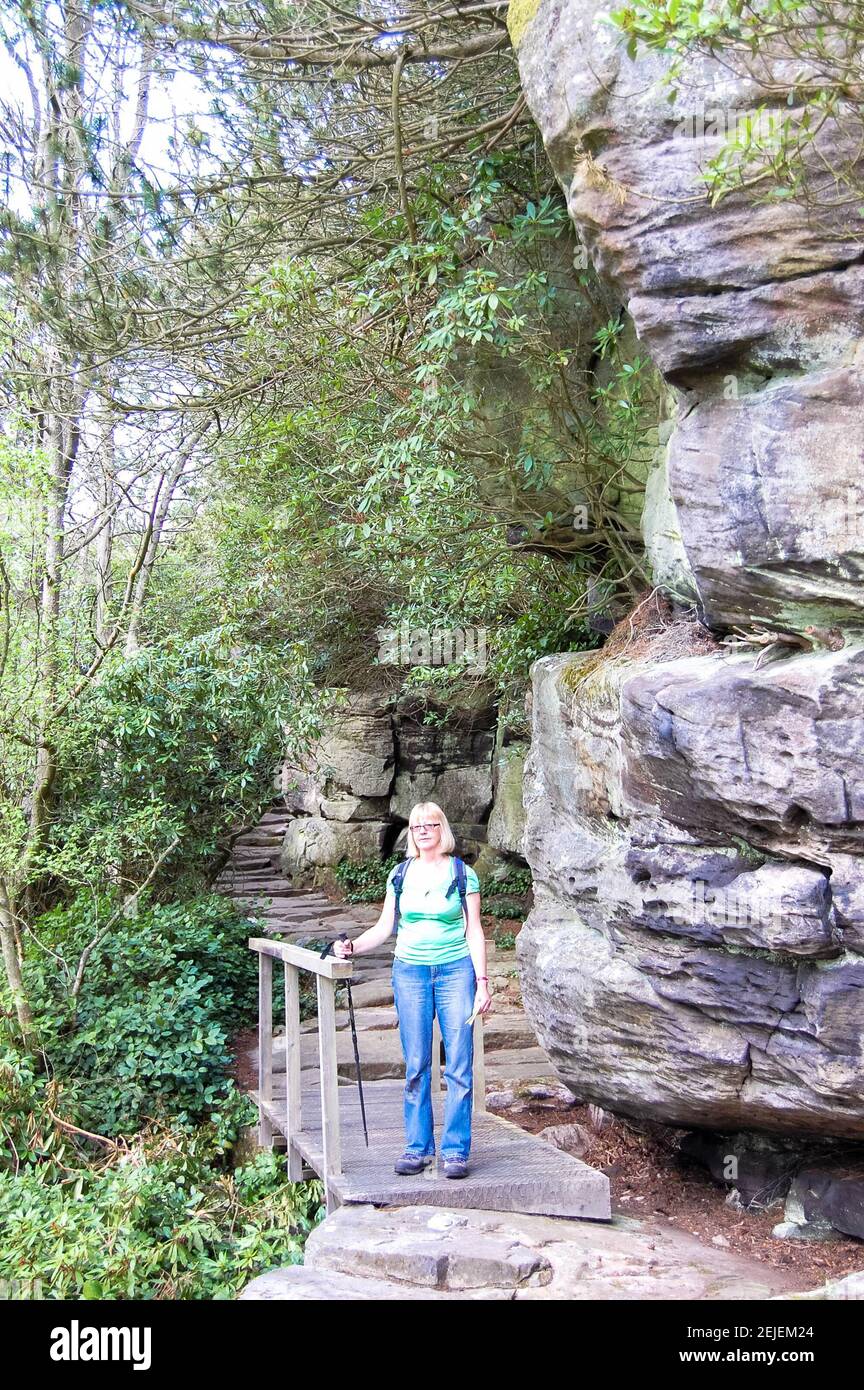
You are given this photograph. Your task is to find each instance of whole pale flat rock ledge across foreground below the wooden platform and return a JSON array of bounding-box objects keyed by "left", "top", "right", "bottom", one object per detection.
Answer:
[{"left": 242, "top": 1200, "right": 800, "bottom": 1302}]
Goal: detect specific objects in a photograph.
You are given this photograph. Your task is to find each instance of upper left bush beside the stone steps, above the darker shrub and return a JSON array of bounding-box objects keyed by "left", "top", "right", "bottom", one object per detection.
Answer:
[{"left": 36, "top": 628, "right": 318, "bottom": 895}]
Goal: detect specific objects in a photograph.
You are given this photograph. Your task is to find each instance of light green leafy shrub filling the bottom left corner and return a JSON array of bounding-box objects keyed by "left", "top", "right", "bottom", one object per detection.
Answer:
[{"left": 0, "top": 1088, "right": 324, "bottom": 1300}]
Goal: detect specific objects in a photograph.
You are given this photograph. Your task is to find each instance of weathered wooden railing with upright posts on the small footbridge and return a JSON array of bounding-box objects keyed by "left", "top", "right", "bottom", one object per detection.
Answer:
[{"left": 249, "top": 937, "right": 486, "bottom": 1209}]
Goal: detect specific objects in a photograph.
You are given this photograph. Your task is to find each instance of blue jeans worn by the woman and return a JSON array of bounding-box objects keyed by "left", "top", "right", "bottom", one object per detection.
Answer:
[{"left": 393, "top": 956, "right": 476, "bottom": 1158}]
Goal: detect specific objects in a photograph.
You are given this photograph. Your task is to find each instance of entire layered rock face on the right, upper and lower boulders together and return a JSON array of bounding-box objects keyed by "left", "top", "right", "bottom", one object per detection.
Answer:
[{"left": 514, "top": 0, "right": 864, "bottom": 1138}]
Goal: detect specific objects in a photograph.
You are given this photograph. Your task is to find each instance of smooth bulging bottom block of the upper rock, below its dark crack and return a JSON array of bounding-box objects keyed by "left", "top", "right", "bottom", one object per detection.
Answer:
[{"left": 668, "top": 372, "right": 864, "bottom": 630}]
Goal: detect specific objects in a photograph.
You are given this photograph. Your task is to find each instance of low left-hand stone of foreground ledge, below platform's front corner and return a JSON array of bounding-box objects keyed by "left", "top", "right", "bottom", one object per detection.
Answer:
[{"left": 304, "top": 1204, "right": 551, "bottom": 1291}]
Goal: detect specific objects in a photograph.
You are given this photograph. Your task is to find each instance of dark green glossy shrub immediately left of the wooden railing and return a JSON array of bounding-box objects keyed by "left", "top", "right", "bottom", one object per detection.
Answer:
[{"left": 29, "top": 895, "right": 257, "bottom": 1134}]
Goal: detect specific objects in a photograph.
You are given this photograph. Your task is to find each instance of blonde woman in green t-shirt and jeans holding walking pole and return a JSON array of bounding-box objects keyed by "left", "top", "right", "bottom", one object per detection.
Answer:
[{"left": 333, "top": 801, "right": 492, "bottom": 1177}]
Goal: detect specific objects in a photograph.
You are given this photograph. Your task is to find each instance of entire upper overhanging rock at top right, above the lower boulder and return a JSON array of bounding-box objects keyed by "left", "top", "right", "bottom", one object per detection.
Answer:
[{"left": 511, "top": 0, "right": 864, "bottom": 630}]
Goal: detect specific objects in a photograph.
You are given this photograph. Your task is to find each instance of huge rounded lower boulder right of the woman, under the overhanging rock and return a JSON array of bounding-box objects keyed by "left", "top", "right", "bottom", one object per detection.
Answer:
[{"left": 517, "top": 646, "right": 864, "bottom": 1138}]
